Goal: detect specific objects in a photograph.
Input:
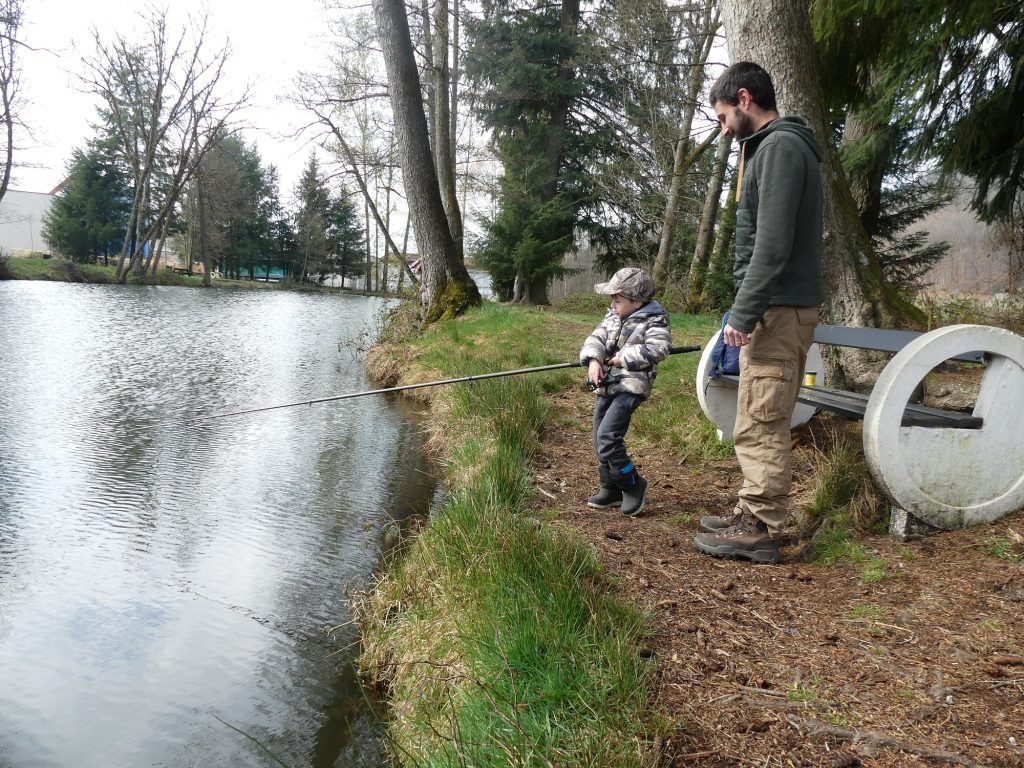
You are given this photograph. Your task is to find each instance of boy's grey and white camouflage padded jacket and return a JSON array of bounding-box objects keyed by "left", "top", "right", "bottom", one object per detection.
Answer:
[{"left": 580, "top": 301, "right": 672, "bottom": 397}]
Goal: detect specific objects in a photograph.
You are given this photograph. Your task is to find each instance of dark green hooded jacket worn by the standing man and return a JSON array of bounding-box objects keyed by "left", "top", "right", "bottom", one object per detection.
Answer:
[{"left": 729, "top": 117, "right": 824, "bottom": 333}]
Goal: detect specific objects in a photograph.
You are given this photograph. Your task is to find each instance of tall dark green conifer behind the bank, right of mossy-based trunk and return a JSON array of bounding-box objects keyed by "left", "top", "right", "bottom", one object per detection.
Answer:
[{"left": 466, "top": 0, "right": 615, "bottom": 303}]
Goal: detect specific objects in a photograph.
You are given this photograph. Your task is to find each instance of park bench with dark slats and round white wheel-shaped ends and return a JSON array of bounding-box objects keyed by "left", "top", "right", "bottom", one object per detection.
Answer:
[{"left": 696, "top": 325, "right": 1024, "bottom": 537}]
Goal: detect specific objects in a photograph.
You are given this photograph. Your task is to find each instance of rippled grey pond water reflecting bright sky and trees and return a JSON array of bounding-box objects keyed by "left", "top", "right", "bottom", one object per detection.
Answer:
[{"left": 0, "top": 283, "right": 433, "bottom": 768}]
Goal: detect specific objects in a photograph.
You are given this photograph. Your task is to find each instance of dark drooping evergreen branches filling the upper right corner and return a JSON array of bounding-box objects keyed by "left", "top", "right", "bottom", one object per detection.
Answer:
[{"left": 811, "top": 0, "right": 1024, "bottom": 228}]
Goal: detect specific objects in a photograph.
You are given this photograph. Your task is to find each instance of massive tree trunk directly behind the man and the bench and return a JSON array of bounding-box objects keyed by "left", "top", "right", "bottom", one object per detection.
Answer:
[{"left": 722, "top": 0, "right": 921, "bottom": 388}]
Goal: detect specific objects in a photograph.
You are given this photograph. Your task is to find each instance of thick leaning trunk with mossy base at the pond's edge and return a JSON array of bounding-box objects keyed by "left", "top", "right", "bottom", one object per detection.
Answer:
[{"left": 373, "top": 0, "right": 480, "bottom": 323}]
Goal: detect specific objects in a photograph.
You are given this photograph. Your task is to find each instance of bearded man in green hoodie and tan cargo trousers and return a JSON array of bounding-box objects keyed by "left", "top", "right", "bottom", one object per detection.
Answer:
[{"left": 693, "top": 61, "right": 824, "bottom": 562}]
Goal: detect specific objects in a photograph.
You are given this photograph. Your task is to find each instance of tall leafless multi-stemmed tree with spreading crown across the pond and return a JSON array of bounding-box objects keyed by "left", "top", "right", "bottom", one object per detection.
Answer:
[{"left": 82, "top": 10, "right": 248, "bottom": 283}]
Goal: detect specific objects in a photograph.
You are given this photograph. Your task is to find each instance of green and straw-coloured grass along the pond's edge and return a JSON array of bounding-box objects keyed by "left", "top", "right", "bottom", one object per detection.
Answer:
[{"left": 360, "top": 304, "right": 715, "bottom": 768}]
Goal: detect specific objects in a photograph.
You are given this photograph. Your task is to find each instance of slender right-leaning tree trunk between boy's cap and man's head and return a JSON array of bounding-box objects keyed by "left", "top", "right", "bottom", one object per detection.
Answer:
[{"left": 653, "top": 2, "right": 720, "bottom": 286}]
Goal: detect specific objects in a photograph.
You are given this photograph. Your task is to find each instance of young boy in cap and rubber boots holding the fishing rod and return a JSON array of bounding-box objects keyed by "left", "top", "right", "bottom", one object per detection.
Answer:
[{"left": 580, "top": 267, "right": 672, "bottom": 517}]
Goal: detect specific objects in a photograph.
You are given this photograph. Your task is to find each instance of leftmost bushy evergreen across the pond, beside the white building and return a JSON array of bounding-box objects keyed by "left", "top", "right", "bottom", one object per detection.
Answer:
[{"left": 43, "top": 139, "right": 132, "bottom": 264}]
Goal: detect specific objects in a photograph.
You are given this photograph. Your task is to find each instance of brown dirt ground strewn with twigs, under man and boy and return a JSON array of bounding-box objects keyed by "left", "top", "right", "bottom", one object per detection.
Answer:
[{"left": 536, "top": 392, "right": 1024, "bottom": 768}]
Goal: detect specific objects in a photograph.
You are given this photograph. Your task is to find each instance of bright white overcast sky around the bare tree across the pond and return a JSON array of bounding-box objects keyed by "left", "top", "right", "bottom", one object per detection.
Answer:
[{"left": 11, "top": 0, "right": 342, "bottom": 201}]
